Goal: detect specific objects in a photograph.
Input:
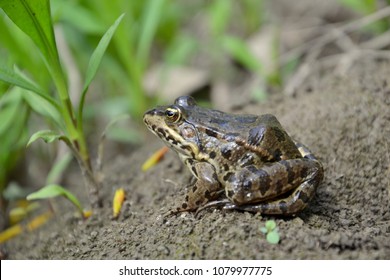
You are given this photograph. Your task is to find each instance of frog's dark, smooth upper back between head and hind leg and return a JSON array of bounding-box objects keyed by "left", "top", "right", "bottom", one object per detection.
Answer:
[{"left": 188, "top": 107, "right": 301, "bottom": 162}]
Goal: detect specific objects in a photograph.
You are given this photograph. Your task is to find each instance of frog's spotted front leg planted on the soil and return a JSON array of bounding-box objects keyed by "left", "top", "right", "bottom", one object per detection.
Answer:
[{"left": 171, "top": 162, "right": 221, "bottom": 214}]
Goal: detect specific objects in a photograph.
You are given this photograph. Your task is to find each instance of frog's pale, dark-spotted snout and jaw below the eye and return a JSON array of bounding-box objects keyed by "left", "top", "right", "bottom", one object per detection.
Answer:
[{"left": 143, "top": 109, "right": 199, "bottom": 158}]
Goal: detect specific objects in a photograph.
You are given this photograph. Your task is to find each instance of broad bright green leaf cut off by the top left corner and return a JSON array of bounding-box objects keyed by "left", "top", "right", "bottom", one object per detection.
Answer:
[{"left": 0, "top": 0, "right": 58, "bottom": 61}]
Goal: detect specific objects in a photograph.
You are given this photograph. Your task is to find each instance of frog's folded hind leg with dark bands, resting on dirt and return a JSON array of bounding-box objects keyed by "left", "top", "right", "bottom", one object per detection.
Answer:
[{"left": 224, "top": 158, "right": 323, "bottom": 215}]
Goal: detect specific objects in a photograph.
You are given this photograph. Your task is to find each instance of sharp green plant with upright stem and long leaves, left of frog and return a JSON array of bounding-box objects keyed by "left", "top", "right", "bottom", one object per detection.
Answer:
[{"left": 0, "top": 0, "right": 123, "bottom": 210}]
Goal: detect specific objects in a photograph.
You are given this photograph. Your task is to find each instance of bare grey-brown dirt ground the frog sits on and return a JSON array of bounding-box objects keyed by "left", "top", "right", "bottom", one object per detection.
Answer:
[{"left": 5, "top": 55, "right": 390, "bottom": 259}]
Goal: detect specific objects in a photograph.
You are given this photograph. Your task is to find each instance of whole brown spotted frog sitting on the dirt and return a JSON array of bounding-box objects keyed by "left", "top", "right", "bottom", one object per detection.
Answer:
[{"left": 143, "top": 96, "right": 324, "bottom": 216}]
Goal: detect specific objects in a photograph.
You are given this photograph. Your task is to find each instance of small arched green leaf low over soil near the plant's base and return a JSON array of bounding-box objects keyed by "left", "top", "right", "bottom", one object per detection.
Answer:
[{"left": 27, "top": 184, "right": 83, "bottom": 215}]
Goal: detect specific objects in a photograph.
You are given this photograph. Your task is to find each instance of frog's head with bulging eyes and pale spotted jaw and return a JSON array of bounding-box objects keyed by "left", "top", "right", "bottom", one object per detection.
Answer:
[{"left": 143, "top": 96, "right": 204, "bottom": 158}]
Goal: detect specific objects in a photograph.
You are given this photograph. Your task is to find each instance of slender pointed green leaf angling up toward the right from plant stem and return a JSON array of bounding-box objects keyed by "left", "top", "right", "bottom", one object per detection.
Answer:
[{"left": 78, "top": 14, "right": 124, "bottom": 124}]
